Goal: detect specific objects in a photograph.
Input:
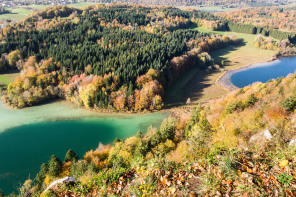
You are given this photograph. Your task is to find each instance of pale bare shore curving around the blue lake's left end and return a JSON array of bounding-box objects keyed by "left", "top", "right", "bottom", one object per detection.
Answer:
[{"left": 215, "top": 56, "right": 280, "bottom": 92}]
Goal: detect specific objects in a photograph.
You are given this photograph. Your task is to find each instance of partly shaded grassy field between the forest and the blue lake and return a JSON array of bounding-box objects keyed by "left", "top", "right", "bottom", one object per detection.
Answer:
[{"left": 169, "top": 27, "right": 276, "bottom": 105}]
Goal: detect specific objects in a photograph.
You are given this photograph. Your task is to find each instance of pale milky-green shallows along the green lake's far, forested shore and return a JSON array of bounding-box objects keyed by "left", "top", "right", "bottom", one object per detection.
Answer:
[{"left": 0, "top": 100, "right": 171, "bottom": 134}]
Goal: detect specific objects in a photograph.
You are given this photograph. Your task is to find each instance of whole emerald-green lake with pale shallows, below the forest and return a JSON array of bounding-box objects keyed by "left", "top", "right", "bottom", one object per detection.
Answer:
[{"left": 0, "top": 102, "right": 168, "bottom": 194}]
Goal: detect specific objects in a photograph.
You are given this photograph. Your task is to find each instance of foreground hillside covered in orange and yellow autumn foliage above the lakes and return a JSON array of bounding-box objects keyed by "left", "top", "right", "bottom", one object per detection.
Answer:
[{"left": 14, "top": 74, "right": 296, "bottom": 196}]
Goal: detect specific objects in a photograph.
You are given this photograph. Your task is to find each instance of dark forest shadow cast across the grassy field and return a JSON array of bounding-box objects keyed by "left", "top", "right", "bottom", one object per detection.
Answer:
[{"left": 164, "top": 39, "right": 246, "bottom": 108}]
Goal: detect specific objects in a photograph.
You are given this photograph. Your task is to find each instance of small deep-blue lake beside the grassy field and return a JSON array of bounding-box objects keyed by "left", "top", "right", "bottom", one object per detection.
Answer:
[{"left": 232, "top": 57, "right": 296, "bottom": 88}]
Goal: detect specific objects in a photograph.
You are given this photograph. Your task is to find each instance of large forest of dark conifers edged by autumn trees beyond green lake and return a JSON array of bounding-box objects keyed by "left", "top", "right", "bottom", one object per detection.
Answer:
[{"left": 0, "top": 5, "right": 239, "bottom": 111}]
